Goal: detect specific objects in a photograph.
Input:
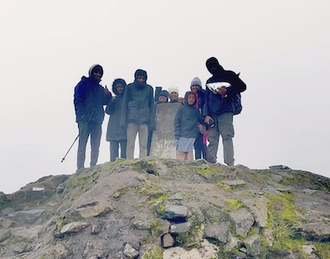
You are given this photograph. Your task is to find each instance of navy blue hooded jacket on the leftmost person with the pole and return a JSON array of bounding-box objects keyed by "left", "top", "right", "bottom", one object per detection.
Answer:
[{"left": 73, "top": 64, "right": 111, "bottom": 123}]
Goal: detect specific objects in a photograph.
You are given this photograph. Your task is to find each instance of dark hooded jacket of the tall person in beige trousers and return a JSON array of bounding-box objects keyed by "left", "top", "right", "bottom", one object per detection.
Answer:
[{"left": 120, "top": 69, "right": 155, "bottom": 129}]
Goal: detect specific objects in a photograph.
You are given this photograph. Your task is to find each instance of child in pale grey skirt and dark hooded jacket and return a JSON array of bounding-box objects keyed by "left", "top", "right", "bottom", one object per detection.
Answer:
[{"left": 174, "top": 91, "right": 204, "bottom": 160}]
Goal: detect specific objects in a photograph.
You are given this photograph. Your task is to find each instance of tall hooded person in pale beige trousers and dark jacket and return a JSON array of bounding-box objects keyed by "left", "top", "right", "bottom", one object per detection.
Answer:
[{"left": 120, "top": 69, "right": 155, "bottom": 159}]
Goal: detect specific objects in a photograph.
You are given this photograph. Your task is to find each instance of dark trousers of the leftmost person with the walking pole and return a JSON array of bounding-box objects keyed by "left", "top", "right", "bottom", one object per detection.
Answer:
[{"left": 77, "top": 122, "right": 102, "bottom": 169}]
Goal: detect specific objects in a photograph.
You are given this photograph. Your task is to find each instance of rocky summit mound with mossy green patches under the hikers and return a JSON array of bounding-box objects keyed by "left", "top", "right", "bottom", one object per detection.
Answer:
[{"left": 0, "top": 157, "right": 330, "bottom": 259}]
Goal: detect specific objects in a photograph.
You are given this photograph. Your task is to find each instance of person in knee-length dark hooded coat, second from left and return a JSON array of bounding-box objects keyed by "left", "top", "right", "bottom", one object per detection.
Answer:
[{"left": 105, "top": 78, "right": 127, "bottom": 161}]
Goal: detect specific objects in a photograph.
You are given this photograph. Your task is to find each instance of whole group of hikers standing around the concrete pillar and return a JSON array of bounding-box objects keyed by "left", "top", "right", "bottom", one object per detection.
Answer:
[{"left": 74, "top": 57, "right": 246, "bottom": 174}]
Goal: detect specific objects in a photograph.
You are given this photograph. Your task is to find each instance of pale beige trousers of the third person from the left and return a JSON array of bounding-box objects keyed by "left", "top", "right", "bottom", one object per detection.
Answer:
[{"left": 126, "top": 123, "right": 149, "bottom": 159}]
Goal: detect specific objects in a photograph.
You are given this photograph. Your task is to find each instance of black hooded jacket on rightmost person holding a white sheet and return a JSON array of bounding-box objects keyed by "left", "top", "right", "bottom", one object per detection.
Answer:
[{"left": 203, "top": 57, "right": 246, "bottom": 117}]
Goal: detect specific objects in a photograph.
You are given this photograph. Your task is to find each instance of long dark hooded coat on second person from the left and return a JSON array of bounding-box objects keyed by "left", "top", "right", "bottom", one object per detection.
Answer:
[{"left": 105, "top": 78, "right": 127, "bottom": 141}]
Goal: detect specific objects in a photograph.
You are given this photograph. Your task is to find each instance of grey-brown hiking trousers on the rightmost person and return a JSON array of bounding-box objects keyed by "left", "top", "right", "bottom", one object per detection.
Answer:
[{"left": 207, "top": 112, "right": 235, "bottom": 165}]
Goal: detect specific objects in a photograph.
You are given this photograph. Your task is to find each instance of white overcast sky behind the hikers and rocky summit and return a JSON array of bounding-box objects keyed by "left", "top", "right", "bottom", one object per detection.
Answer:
[{"left": 0, "top": 0, "right": 330, "bottom": 193}]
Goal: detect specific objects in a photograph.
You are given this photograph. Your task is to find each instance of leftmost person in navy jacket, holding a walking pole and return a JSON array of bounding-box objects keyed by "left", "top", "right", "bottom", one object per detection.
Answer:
[{"left": 73, "top": 64, "right": 111, "bottom": 171}]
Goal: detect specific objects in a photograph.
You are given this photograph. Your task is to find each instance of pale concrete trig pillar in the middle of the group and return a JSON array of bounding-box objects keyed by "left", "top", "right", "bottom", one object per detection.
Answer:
[{"left": 150, "top": 103, "right": 182, "bottom": 158}]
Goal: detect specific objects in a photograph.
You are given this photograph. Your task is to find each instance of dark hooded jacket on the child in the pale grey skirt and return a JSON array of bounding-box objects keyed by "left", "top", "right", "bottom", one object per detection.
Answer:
[{"left": 174, "top": 91, "right": 204, "bottom": 139}]
